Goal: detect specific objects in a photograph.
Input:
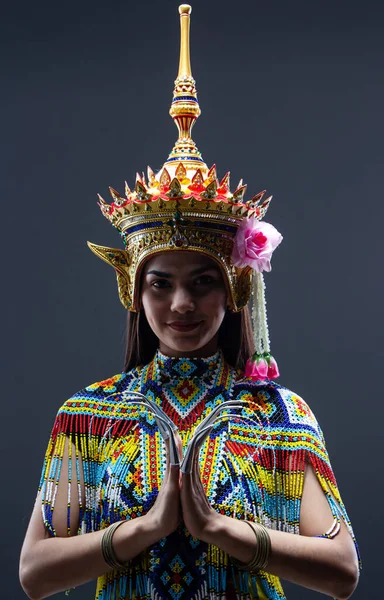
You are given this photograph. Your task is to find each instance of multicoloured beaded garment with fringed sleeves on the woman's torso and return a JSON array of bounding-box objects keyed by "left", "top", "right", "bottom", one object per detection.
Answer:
[{"left": 39, "top": 350, "right": 360, "bottom": 600}]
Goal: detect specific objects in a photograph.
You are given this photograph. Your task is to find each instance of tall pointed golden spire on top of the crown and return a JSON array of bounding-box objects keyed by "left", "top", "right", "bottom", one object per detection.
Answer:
[{"left": 164, "top": 4, "right": 208, "bottom": 175}]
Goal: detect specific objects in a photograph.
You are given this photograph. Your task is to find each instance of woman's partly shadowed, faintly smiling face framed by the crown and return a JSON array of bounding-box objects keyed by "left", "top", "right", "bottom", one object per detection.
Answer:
[{"left": 141, "top": 251, "right": 227, "bottom": 357}]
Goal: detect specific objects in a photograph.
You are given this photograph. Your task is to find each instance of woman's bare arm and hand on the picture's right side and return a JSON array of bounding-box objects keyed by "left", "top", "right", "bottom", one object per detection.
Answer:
[{"left": 181, "top": 466, "right": 359, "bottom": 600}]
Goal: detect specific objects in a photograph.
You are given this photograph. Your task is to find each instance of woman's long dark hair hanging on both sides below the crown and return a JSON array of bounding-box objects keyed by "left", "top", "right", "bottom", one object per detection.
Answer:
[{"left": 124, "top": 306, "right": 255, "bottom": 371}]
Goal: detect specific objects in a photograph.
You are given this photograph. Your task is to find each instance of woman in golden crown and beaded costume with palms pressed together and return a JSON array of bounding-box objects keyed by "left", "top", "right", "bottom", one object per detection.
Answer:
[{"left": 20, "top": 5, "right": 358, "bottom": 600}]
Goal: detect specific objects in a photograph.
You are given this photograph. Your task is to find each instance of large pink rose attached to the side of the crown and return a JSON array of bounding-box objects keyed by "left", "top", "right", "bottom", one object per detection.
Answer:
[{"left": 232, "top": 217, "right": 283, "bottom": 273}]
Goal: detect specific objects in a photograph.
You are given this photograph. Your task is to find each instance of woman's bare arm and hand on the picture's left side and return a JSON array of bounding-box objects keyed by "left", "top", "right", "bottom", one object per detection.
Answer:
[{"left": 20, "top": 440, "right": 179, "bottom": 600}]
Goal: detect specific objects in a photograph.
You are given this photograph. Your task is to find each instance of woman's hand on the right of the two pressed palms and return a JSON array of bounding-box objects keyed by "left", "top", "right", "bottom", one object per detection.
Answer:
[{"left": 180, "top": 449, "right": 222, "bottom": 542}]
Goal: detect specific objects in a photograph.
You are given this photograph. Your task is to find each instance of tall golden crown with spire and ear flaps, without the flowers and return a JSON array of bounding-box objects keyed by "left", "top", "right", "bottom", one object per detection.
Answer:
[{"left": 88, "top": 4, "right": 271, "bottom": 312}]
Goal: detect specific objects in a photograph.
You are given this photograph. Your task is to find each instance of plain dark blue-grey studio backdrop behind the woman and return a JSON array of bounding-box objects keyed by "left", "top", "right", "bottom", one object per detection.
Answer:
[{"left": 0, "top": 0, "right": 384, "bottom": 600}]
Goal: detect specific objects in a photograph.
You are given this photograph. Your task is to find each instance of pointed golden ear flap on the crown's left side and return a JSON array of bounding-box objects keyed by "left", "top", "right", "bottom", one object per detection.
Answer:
[{"left": 87, "top": 242, "right": 136, "bottom": 312}]
